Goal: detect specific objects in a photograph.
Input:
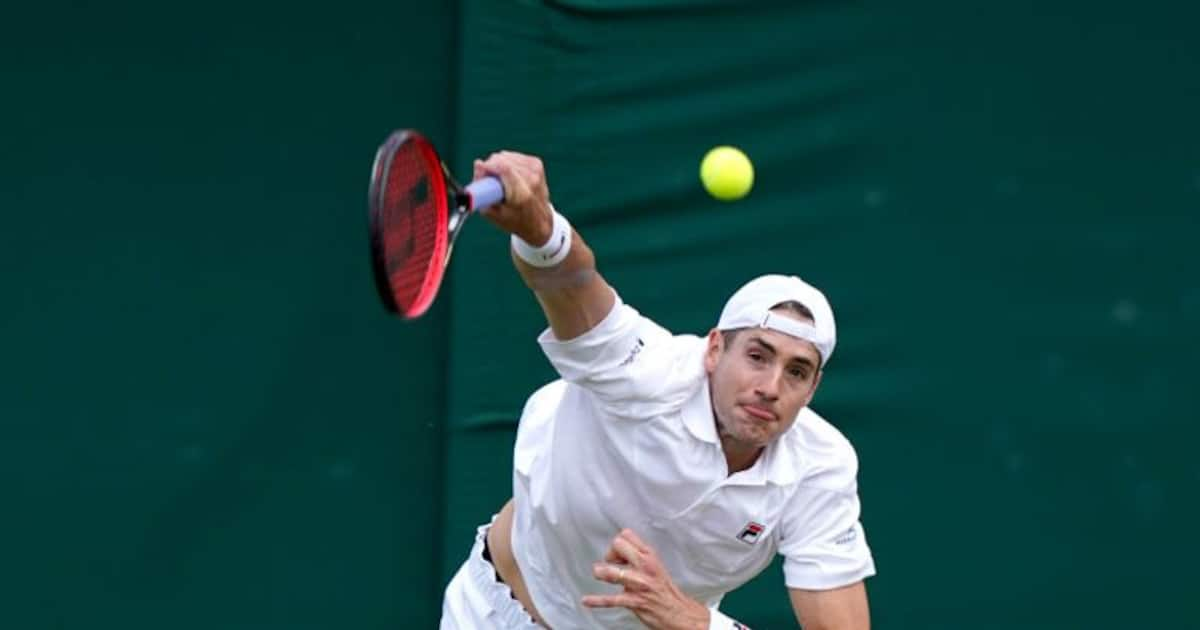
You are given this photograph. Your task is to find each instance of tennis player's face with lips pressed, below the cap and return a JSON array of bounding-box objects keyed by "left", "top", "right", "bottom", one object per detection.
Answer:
[{"left": 704, "top": 313, "right": 821, "bottom": 448}]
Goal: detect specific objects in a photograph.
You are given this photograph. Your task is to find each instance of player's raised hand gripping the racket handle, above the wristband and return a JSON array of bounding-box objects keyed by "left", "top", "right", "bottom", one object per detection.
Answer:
[{"left": 474, "top": 151, "right": 553, "bottom": 247}]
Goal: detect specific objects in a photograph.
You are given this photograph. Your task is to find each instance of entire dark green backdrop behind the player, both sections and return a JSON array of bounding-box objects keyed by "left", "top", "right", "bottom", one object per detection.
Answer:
[{"left": 0, "top": 0, "right": 1200, "bottom": 629}]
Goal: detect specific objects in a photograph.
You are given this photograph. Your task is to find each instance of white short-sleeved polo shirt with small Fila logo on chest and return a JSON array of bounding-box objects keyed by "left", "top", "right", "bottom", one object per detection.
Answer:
[{"left": 512, "top": 298, "right": 875, "bottom": 630}]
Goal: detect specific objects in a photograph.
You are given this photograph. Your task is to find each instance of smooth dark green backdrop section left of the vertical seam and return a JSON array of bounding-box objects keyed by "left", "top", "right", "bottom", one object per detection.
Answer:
[{"left": 0, "top": 2, "right": 455, "bottom": 629}]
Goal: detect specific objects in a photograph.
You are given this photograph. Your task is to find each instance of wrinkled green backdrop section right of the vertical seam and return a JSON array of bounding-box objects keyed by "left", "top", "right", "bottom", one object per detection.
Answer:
[{"left": 445, "top": 1, "right": 1200, "bottom": 629}]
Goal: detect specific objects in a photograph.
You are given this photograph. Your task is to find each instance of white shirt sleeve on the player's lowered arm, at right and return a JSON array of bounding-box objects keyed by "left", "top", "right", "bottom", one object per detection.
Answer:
[{"left": 779, "top": 476, "right": 875, "bottom": 590}]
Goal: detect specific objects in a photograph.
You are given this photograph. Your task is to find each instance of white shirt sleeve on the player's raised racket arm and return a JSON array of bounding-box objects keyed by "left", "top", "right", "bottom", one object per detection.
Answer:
[{"left": 538, "top": 291, "right": 703, "bottom": 418}]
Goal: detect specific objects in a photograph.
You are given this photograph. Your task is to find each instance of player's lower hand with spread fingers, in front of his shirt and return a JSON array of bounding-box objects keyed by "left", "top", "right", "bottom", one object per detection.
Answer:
[{"left": 583, "top": 529, "right": 709, "bottom": 630}]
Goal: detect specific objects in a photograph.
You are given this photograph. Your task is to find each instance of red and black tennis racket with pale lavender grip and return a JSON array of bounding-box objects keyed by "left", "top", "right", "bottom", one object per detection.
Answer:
[{"left": 368, "top": 130, "right": 504, "bottom": 319}]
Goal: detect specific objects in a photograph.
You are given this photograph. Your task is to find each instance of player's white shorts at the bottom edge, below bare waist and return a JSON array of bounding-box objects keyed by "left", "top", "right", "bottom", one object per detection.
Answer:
[{"left": 440, "top": 516, "right": 544, "bottom": 630}]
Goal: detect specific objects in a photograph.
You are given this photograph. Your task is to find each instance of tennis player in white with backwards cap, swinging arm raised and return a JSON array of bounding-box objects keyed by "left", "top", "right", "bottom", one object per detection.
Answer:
[{"left": 442, "top": 151, "right": 875, "bottom": 630}]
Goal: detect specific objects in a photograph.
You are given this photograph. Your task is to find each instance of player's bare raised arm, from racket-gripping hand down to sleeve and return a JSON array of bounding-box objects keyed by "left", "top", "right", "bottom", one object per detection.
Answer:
[{"left": 474, "top": 151, "right": 616, "bottom": 341}]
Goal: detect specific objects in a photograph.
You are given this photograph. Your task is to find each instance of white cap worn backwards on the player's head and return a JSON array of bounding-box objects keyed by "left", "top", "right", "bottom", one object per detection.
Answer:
[{"left": 716, "top": 274, "right": 838, "bottom": 367}]
